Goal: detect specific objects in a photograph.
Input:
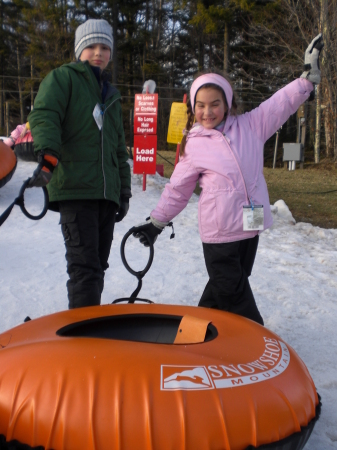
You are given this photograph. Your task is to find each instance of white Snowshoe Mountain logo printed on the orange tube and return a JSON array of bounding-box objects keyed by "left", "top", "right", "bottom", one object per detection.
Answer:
[{"left": 161, "top": 337, "right": 290, "bottom": 391}]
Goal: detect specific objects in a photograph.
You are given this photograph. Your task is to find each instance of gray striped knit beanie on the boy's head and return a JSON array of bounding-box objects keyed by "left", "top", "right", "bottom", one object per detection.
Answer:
[{"left": 75, "top": 19, "right": 113, "bottom": 59}]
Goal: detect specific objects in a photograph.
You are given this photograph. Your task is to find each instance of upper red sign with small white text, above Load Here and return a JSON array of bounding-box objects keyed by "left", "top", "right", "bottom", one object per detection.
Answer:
[{"left": 133, "top": 94, "right": 158, "bottom": 134}]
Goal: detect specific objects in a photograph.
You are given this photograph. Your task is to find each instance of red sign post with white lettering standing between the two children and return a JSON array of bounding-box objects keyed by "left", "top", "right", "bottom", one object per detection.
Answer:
[{"left": 133, "top": 93, "right": 158, "bottom": 191}]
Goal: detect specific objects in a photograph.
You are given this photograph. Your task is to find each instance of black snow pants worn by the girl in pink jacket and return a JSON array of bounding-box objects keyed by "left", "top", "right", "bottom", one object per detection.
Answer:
[{"left": 199, "top": 236, "right": 264, "bottom": 325}]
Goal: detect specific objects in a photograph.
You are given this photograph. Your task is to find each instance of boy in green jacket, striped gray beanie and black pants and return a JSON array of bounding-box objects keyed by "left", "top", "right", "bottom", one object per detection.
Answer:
[{"left": 28, "top": 19, "right": 131, "bottom": 309}]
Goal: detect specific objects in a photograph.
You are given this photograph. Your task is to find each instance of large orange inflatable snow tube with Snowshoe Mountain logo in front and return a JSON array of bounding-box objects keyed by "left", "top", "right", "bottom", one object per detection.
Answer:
[{"left": 0, "top": 303, "right": 320, "bottom": 450}]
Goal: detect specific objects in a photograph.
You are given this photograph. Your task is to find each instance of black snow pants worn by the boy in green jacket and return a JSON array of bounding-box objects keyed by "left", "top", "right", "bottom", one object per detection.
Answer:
[{"left": 59, "top": 200, "right": 118, "bottom": 309}]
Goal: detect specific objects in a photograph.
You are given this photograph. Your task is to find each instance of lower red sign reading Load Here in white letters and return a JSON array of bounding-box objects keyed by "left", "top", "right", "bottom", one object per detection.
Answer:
[{"left": 133, "top": 134, "right": 157, "bottom": 175}]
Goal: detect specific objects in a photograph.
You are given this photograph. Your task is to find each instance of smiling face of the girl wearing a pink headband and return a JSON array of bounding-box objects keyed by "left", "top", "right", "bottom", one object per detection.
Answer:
[{"left": 194, "top": 88, "right": 227, "bottom": 129}]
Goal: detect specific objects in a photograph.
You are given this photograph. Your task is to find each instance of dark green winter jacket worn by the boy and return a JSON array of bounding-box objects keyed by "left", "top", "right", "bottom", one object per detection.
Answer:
[{"left": 28, "top": 62, "right": 131, "bottom": 210}]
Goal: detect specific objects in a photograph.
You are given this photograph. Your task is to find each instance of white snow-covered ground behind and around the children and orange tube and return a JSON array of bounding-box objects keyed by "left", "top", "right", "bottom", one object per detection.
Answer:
[{"left": 0, "top": 161, "right": 337, "bottom": 450}]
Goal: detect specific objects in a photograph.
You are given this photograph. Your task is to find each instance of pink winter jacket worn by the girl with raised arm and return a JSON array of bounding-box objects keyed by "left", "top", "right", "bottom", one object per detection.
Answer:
[{"left": 151, "top": 78, "right": 313, "bottom": 243}]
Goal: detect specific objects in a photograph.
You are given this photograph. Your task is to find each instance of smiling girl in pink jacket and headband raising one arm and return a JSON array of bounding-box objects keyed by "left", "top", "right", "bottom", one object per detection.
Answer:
[{"left": 134, "top": 35, "right": 322, "bottom": 325}]
